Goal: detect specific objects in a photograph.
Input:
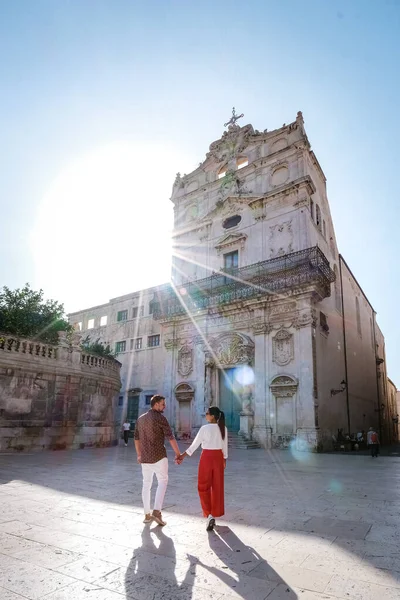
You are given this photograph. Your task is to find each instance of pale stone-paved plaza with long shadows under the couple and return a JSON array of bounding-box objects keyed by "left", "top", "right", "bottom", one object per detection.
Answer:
[{"left": 0, "top": 442, "right": 400, "bottom": 600}]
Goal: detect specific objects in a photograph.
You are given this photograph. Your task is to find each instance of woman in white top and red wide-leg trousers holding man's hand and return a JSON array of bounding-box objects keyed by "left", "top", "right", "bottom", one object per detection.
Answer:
[{"left": 176, "top": 406, "right": 228, "bottom": 531}]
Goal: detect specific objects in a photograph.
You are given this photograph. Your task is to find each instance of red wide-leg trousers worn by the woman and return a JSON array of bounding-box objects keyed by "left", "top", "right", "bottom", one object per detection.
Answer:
[{"left": 197, "top": 450, "right": 224, "bottom": 517}]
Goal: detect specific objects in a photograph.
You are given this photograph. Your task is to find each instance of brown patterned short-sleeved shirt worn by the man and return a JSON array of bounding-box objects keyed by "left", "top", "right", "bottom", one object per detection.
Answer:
[{"left": 134, "top": 409, "right": 175, "bottom": 463}]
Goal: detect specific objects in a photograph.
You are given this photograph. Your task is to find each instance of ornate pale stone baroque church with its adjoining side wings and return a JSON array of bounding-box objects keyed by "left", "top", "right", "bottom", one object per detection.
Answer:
[{"left": 69, "top": 111, "right": 393, "bottom": 449}]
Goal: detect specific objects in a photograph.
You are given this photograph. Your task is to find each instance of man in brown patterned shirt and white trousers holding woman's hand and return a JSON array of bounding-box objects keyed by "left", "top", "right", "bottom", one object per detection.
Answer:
[{"left": 134, "top": 394, "right": 180, "bottom": 525}]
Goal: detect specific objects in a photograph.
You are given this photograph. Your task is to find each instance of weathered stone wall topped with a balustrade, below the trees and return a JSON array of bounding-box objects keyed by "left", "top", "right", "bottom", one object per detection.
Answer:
[{"left": 0, "top": 332, "right": 121, "bottom": 452}]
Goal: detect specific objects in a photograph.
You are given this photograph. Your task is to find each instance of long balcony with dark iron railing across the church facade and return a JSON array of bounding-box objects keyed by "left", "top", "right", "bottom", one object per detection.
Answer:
[{"left": 153, "top": 246, "right": 335, "bottom": 320}]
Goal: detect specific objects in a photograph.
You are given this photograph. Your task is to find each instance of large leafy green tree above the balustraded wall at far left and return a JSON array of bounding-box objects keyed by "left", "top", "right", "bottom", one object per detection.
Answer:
[{"left": 0, "top": 283, "right": 73, "bottom": 344}]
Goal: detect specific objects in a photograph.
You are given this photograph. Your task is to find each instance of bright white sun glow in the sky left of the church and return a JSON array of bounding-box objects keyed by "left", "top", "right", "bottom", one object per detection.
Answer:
[{"left": 31, "top": 141, "right": 194, "bottom": 311}]
